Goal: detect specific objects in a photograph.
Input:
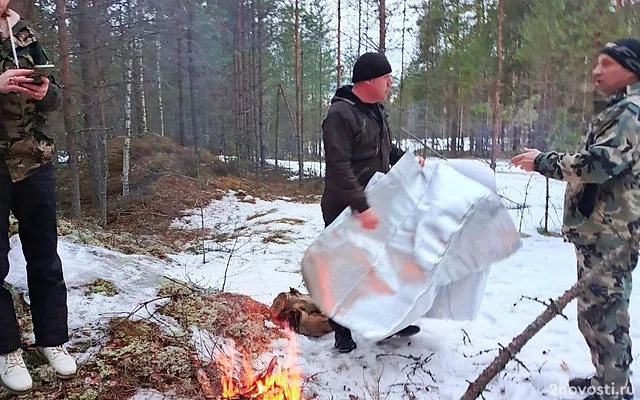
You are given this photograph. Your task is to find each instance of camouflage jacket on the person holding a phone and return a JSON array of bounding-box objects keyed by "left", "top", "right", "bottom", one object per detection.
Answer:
[{"left": 0, "top": 20, "right": 62, "bottom": 182}]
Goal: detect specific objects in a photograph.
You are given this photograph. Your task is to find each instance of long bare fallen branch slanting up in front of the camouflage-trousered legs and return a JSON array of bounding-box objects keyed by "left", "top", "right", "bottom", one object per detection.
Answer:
[{"left": 460, "top": 242, "right": 632, "bottom": 400}]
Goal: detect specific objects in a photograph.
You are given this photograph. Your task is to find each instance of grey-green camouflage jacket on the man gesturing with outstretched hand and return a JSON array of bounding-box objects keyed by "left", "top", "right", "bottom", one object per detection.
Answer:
[{"left": 534, "top": 83, "right": 640, "bottom": 245}]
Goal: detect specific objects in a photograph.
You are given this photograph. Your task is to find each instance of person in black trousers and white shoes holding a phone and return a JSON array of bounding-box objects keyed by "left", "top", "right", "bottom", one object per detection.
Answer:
[{"left": 0, "top": 0, "right": 76, "bottom": 394}]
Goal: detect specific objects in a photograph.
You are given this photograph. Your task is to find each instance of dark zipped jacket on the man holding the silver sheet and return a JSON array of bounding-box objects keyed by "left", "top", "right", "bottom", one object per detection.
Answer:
[{"left": 322, "top": 85, "right": 404, "bottom": 219}]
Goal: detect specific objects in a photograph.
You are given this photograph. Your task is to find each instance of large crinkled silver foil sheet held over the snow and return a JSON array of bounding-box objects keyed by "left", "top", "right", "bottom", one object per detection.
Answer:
[{"left": 302, "top": 153, "right": 520, "bottom": 340}]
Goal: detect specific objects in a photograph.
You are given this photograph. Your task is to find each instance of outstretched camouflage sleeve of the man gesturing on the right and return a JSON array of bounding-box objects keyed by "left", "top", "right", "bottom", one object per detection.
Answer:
[{"left": 534, "top": 105, "right": 640, "bottom": 183}]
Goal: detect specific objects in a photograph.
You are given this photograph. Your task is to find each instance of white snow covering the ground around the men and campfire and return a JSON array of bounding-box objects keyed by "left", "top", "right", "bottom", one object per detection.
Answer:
[{"left": 8, "top": 157, "right": 640, "bottom": 400}]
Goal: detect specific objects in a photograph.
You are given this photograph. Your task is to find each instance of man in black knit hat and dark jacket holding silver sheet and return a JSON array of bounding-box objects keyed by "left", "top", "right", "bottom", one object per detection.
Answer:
[{"left": 321, "top": 53, "right": 424, "bottom": 353}]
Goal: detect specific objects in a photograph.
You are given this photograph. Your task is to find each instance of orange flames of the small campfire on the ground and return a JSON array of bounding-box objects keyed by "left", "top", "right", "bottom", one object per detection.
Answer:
[{"left": 217, "top": 328, "right": 304, "bottom": 400}]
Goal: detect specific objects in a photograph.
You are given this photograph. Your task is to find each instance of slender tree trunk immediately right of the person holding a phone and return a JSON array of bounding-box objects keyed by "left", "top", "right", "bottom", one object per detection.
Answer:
[{"left": 54, "top": 0, "right": 82, "bottom": 219}]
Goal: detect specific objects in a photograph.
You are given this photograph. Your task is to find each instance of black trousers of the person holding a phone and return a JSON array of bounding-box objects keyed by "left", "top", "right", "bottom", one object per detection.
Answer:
[{"left": 0, "top": 164, "right": 69, "bottom": 354}]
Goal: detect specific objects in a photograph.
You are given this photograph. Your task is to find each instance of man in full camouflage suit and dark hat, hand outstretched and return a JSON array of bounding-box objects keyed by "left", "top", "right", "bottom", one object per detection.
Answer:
[{"left": 512, "top": 38, "right": 640, "bottom": 400}]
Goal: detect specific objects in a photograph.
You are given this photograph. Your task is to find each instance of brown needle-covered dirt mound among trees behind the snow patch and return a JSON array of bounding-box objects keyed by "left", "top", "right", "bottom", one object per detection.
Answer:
[{"left": 58, "top": 136, "right": 322, "bottom": 256}]
